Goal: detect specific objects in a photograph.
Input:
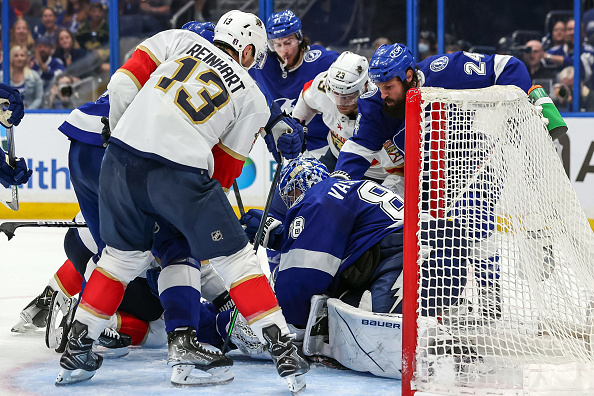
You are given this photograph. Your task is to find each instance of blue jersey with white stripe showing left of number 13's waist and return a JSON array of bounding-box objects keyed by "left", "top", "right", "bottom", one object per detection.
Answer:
[{"left": 58, "top": 91, "right": 109, "bottom": 146}]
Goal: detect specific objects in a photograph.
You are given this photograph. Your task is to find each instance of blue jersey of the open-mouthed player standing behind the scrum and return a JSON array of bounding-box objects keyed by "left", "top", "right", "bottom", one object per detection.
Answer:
[{"left": 249, "top": 45, "right": 338, "bottom": 150}]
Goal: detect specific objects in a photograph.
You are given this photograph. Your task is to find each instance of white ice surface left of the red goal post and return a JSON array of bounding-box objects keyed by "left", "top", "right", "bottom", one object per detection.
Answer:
[{"left": 0, "top": 224, "right": 401, "bottom": 396}]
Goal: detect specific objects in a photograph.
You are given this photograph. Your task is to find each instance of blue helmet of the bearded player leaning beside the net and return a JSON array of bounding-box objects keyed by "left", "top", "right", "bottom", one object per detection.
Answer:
[{"left": 369, "top": 43, "right": 415, "bottom": 83}]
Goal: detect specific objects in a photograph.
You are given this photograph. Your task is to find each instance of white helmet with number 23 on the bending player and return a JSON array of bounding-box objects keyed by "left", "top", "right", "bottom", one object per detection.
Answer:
[{"left": 326, "top": 51, "right": 369, "bottom": 106}]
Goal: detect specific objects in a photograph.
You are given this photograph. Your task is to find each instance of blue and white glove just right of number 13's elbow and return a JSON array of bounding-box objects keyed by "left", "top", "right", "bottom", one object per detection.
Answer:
[{"left": 262, "top": 102, "right": 305, "bottom": 163}]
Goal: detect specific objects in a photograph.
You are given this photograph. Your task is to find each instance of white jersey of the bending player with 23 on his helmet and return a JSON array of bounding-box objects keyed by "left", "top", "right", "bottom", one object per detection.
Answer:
[{"left": 292, "top": 71, "right": 394, "bottom": 180}]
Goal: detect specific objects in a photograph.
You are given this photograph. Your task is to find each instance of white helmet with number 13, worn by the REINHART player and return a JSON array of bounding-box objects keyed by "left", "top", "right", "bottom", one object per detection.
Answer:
[{"left": 214, "top": 10, "right": 267, "bottom": 69}]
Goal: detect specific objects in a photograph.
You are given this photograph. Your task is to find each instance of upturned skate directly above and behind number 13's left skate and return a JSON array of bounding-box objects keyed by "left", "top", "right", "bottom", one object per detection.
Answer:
[{"left": 45, "top": 290, "right": 77, "bottom": 353}]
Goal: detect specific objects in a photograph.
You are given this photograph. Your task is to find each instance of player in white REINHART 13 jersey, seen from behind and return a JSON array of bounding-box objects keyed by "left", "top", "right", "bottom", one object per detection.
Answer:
[{"left": 56, "top": 11, "right": 308, "bottom": 392}]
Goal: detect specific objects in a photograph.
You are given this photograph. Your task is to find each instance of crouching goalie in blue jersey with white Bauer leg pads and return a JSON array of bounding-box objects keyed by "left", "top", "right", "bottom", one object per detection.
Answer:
[{"left": 273, "top": 158, "right": 466, "bottom": 378}]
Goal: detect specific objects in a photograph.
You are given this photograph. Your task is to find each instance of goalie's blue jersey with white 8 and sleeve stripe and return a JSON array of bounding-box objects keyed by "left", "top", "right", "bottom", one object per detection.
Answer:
[{"left": 275, "top": 178, "right": 404, "bottom": 325}]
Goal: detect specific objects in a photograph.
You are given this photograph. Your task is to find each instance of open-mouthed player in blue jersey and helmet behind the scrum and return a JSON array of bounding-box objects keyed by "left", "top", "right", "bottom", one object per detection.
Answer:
[{"left": 250, "top": 10, "right": 338, "bottom": 158}]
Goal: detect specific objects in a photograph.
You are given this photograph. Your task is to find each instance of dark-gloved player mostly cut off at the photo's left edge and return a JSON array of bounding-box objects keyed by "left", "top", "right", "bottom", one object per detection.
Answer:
[{"left": 0, "top": 83, "right": 33, "bottom": 188}]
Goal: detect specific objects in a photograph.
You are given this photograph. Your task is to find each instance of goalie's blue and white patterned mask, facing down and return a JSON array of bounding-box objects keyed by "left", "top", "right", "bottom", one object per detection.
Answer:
[{"left": 278, "top": 156, "right": 329, "bottom": 208}]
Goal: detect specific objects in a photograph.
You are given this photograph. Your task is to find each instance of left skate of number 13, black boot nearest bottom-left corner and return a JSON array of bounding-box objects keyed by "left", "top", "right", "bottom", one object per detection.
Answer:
[{"left": 56, "top": 320, "right": 103, "bottom": 385}]
